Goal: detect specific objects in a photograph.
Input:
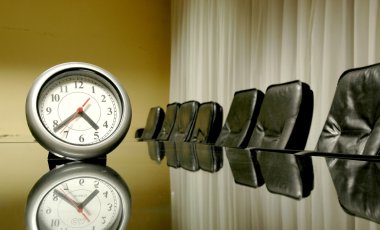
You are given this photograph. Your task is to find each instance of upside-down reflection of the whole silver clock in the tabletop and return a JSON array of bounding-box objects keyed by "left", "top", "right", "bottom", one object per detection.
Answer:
[{"left": 25, "top": 153, "right": 131, "bottom": 230}]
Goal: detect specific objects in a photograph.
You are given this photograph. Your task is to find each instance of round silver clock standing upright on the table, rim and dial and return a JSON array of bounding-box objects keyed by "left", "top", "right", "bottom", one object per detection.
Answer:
[{"left": 26, "top": 62, "right": 132, "bottom": 160}]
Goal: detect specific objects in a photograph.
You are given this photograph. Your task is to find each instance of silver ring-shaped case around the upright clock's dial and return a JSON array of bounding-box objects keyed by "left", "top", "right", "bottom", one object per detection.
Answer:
[{"left": 25, "top": 62, "right": 132, "bottom": 160}]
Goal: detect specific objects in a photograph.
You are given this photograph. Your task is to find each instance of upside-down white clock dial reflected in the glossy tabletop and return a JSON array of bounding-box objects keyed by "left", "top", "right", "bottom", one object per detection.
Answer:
[{"left": 37, "top": 177, "right": 122, "bottom": 230}]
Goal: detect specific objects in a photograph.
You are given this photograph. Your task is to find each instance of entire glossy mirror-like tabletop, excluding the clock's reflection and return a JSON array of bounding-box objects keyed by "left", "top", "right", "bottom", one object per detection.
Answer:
[{"left": 0, "top": 139, "right": 380, "bottom": 229}]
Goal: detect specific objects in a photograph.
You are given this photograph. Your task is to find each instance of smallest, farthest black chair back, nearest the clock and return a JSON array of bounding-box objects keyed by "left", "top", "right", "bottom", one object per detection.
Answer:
[{"left": 141, "top": 106, "right": 165, "bottom": 140}]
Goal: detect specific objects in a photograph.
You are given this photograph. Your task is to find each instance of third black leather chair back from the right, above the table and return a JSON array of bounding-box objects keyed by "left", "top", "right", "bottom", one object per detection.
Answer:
[{"left": 215, "top": 89, "right": 264, "bottom": 147}]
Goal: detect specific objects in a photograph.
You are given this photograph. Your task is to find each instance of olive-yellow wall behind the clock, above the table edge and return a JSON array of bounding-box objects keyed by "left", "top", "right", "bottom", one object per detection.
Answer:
[{"left": 0, "top": 0, "right": 170, "bottom": 141}]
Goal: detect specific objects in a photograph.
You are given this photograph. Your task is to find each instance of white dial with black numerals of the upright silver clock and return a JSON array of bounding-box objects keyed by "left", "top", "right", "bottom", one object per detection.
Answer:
[{"left": 37, "top": 70, "right": 122, "bottom": 145}]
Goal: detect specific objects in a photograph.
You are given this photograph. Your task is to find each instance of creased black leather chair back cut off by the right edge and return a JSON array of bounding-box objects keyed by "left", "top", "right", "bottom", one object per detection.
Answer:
[{"left": 317, "top": 64, "right": 380, "bottom": 155}]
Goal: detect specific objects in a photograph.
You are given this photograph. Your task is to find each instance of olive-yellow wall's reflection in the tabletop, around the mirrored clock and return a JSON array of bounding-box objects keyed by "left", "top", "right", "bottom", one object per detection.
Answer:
[{"left": 0, "top": 138, "right": 171, "bottom": 229}]
